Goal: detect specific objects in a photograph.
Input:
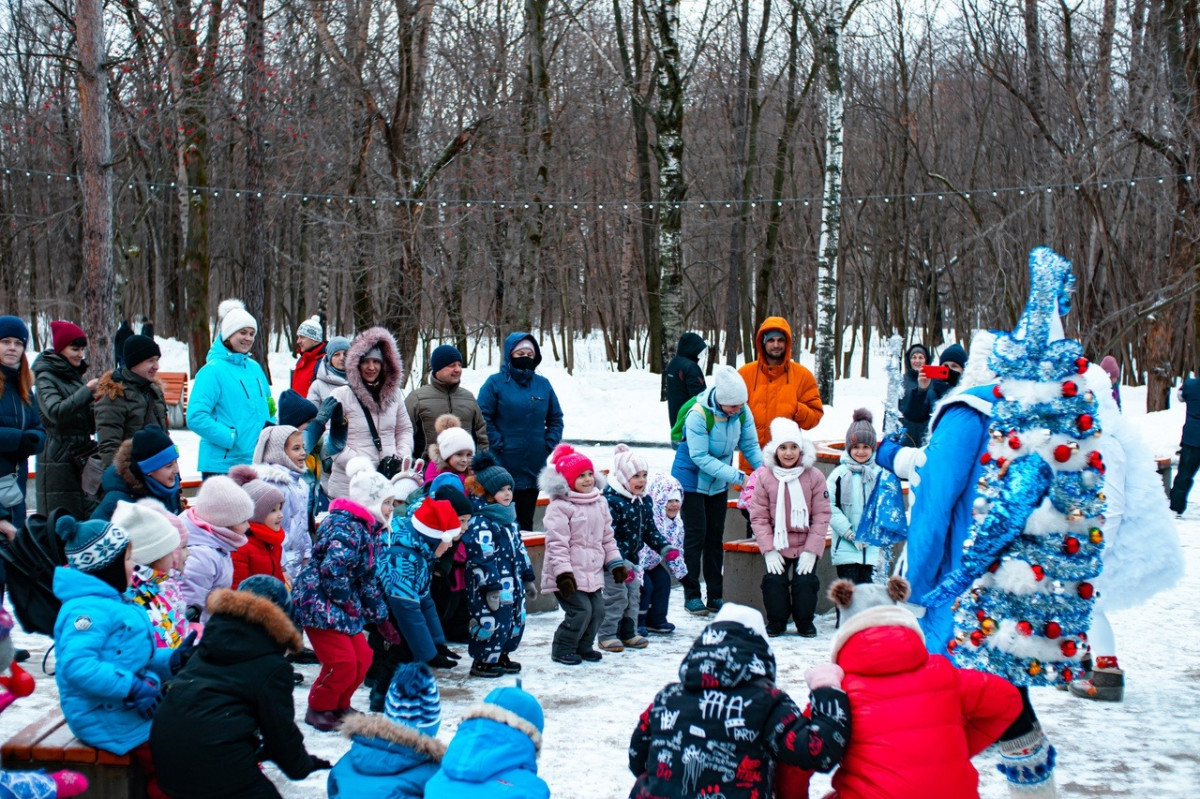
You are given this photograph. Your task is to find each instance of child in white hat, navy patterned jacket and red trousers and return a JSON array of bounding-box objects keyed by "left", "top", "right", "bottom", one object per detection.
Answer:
[{"left": 294, "top": 458, "right": 394, "bottom": 732}]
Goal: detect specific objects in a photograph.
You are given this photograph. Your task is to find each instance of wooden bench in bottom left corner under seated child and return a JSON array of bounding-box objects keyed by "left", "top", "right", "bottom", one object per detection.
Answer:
[{"left": 0, "top": 709, "right": 145, "bottom": 799}]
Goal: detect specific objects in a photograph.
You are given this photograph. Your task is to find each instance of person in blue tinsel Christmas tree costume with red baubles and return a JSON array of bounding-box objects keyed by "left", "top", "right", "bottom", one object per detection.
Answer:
[{"left": 919, "top": 247, "right": 1105, "bottom": 797}]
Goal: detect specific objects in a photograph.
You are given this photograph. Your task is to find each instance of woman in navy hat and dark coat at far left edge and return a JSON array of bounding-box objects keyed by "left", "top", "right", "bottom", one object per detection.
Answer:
[{"left": 0, "top": 317, "right": 46, "bottom": 547}]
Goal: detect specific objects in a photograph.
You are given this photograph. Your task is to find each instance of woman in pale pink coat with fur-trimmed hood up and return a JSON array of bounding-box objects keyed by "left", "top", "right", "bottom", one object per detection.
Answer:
[{"left": 325, "top": 328, "right": 413, "bottom": 497}]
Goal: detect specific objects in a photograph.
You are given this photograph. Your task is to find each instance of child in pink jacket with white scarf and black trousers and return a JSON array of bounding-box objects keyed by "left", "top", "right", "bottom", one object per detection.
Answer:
[{"left": 750, "top": 417, "right": 830, "bottom": 638}]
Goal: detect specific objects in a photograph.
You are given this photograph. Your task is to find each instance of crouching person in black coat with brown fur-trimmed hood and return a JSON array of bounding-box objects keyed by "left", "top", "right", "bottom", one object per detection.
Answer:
[{"left": 150, "top": 575, "right": 330, "bottom": 799}]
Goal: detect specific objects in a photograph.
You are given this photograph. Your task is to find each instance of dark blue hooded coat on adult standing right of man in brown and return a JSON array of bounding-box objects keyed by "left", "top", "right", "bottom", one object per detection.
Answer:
[{"left": 479, "top": 332, "right": 563, "bottom": 491}]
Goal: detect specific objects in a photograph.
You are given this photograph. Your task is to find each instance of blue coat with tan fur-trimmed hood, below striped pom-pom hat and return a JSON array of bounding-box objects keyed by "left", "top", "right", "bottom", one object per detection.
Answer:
[{"left": 326, "top": 714, "right": 446, "bottom": 799}]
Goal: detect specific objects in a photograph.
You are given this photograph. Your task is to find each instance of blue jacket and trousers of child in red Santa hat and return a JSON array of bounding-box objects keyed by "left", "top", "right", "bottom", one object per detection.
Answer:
[{"left": 379, "top": 505, "right": 446, "bottom": 663}]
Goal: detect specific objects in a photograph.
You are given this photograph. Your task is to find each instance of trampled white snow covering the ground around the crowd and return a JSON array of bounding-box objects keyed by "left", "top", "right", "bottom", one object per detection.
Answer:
[{"left": 9, "top": 328, "right": 1200, "bottom": 799}]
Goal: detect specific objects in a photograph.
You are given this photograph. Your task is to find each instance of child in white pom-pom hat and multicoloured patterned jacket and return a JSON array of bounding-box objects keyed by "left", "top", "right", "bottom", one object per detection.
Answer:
[{"left": 120, "top": 499, "right": 188, "bottom": 649}]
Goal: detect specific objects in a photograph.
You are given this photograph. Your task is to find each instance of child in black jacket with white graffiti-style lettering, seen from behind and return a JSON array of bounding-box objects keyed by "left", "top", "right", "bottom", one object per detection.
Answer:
[{"left": 629, "top": 602, "right": 849, "bottom": 799}]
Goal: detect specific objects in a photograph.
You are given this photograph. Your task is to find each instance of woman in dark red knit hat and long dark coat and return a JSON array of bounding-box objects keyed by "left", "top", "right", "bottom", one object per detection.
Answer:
[{"left": 34, "top": 320, "right": 100, "bottom": 518}]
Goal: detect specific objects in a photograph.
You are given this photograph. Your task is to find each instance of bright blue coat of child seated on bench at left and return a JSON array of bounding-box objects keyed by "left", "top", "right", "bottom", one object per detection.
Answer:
[{"left": 54, "top": 566, "right": 172, "bottom": 755}]
